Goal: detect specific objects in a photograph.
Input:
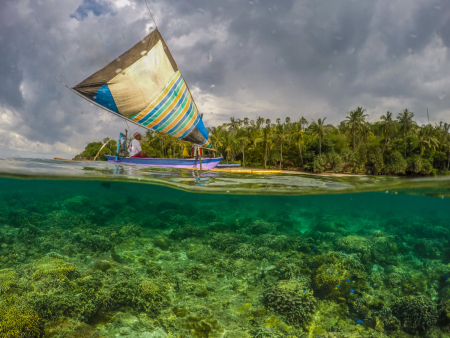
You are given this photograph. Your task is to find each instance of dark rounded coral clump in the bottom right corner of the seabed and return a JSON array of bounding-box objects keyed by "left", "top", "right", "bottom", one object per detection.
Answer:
[{"left": 392, "top": 296, "right": 438, "bottom": 334}]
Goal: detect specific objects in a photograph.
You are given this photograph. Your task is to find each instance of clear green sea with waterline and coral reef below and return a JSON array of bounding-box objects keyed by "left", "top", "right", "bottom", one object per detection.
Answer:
[{"left": 0, "top": 159, "right": 450, "bottom": 338}]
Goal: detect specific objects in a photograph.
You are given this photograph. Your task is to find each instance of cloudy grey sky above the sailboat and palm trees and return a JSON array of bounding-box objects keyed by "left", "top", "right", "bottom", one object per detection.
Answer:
[{"left": 0, "top": 0, "right": 450, "bottom": 158}]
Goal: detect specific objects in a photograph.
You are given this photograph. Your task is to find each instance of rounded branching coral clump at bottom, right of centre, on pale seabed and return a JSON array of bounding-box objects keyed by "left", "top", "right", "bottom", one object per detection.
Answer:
[{"left": 265, "top": 280, "right": 316, "bottom": 325}]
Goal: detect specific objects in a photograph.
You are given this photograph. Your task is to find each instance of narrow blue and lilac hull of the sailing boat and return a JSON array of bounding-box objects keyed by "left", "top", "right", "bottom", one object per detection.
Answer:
[{"left": 105, "top": 155, "right": 222, "bottom": 169}]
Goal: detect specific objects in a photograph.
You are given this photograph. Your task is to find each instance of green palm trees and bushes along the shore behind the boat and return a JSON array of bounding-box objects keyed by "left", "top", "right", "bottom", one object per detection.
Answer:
[{"left": 75, "top": 107, "right": 450, "bottom": 176}]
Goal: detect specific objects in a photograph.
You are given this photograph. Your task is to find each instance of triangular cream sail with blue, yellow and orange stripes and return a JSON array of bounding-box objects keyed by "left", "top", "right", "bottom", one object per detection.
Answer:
[{"left": 73, "top": 29, "right": 212, "bottom": 148}]
